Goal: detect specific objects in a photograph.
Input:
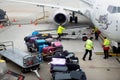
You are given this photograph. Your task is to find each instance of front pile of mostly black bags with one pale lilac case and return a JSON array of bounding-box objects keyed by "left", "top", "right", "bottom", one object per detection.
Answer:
[{"left": 49, "top": 50, "right": 86, "bottom": 80}]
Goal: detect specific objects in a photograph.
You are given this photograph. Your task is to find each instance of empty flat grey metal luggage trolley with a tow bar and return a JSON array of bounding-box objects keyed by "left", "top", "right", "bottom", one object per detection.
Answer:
[{"left": 0, "top": 41, "right": 42, "bottom": 79}]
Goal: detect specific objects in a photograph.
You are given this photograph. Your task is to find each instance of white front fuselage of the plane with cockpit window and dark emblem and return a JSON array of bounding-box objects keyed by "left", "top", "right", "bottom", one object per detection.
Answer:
[{"left": 90, "top": 0, "right": 120, "bottom": 42}]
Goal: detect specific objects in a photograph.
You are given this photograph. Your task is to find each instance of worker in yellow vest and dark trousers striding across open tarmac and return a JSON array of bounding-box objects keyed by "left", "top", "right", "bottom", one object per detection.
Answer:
[{"left": 82, "top": 37, "right": 93, "bottom": 61}]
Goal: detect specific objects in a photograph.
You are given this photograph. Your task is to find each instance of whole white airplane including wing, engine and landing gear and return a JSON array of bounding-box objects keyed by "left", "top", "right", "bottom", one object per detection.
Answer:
[{"left": 9, "top": 0, "right": 120, "bottom": 47}]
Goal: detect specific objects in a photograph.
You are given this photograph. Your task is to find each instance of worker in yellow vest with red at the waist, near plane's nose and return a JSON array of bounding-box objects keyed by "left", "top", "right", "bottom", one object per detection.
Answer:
[{"left": 103, "top": 37, "right": 110, "bottom": 59}]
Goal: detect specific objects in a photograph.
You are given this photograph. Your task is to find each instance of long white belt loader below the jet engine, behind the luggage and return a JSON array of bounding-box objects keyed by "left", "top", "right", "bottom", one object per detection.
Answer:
[{"left": 36, "top": 26, "right": 91, "bottom": 41}]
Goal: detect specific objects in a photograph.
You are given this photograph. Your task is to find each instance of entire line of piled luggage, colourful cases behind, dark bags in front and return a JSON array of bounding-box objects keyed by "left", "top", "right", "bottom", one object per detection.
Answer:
[{"left": 24, "top": 32, "right": 87, "bottom": 80}]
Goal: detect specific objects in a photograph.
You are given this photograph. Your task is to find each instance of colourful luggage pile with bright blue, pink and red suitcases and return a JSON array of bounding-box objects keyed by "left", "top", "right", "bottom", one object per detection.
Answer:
[{"left": 24, "top": 32, "right": 63, "bottom": 61}]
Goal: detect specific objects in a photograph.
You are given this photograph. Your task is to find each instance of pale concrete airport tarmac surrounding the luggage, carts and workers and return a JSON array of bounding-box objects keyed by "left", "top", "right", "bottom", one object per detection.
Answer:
[{"left": 0, "top": 0, "right": 120, "bottom": 80}]
